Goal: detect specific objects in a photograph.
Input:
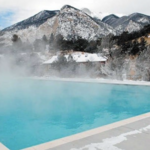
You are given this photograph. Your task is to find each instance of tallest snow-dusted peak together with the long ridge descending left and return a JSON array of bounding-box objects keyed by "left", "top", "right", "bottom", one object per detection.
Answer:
[{"left": 2, "top": 5, "right": 116, "bottom": 43}]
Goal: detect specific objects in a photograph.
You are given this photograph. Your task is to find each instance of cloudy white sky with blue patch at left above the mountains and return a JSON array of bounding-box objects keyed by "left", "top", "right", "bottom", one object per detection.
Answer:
[{"left": 0, "top": 0, "right": 150, "bottom": 28}]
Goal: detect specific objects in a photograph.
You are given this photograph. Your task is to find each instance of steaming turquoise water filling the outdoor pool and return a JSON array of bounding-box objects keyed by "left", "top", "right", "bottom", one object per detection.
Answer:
[{"left": 0, "top": 80, "right": 150, "bottom": 150}]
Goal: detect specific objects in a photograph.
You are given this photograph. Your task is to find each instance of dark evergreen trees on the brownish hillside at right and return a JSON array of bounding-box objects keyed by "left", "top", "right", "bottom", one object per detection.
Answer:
[{"left": 111, "top": 25, "right": 150, "bottom": 55}]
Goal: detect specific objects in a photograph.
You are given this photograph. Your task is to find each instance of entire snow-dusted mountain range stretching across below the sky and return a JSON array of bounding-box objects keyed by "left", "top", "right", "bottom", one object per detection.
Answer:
[{"left": 0, "top": 5, "right": 150, "bottom": 45}]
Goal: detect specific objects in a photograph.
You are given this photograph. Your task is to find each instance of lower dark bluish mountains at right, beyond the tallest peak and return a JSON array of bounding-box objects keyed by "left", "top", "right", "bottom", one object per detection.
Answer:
[{"left": 102, "top": 13, "right": 150, "bottom": 33}]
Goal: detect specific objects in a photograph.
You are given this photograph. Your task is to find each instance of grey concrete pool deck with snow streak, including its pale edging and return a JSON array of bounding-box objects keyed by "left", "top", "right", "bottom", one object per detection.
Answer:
[{"left": 21, "top": 113, "right": 150, "bottom": 150}]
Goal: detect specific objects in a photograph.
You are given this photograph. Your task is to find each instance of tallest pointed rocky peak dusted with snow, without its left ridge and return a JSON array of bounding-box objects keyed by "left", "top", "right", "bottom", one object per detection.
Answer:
[{"left": 48, "top": 5, "right": 113, "bottom": 40}]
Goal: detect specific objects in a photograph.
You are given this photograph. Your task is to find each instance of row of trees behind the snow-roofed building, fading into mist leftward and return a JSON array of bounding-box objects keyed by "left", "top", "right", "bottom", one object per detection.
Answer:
[{"left": 5, "top": 34, "right": 101, "bottom": 53}]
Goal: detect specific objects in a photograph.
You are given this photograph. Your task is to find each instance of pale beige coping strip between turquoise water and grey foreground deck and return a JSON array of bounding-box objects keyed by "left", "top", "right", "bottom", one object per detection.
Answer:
[{"left": 22, "top": 112, "right": 150, "bottom": 150}]
